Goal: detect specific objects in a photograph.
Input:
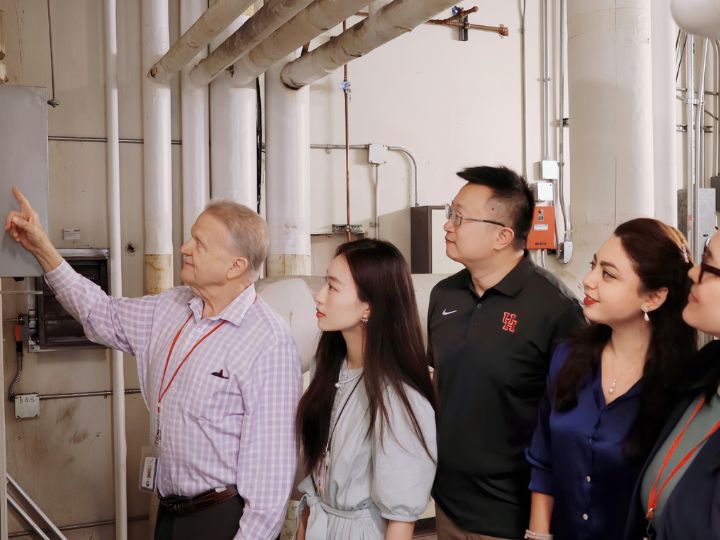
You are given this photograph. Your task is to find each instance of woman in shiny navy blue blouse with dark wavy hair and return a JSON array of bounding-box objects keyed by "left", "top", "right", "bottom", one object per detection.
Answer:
[{"left": 525, "top": 218, "right": 696, "bottom": 540}]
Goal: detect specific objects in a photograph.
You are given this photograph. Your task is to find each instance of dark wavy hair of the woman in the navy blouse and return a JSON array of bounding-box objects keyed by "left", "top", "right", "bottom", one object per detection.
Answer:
[{"left": 554, "top": 218, "right": 697, "bottom": 460}]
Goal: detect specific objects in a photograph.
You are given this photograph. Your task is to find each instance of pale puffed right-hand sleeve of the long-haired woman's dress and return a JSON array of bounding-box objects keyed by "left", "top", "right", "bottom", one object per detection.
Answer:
[{"left": 371, "top": 385, "right": 437, "bottom": 521}]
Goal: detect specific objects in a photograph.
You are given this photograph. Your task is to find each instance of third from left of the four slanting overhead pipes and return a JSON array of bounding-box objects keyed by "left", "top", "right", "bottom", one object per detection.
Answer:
[{"left": 233, "top": 0, "right": 368, "bottom": 84}]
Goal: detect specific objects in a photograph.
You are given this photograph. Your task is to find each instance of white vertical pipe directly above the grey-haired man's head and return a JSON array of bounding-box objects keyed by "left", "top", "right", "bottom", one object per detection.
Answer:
[{"left": 210, "top": 16, "right": 257, "bottom": 209}]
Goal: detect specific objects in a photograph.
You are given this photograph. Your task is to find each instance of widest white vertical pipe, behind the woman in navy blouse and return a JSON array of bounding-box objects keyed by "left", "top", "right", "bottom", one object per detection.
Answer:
[{"left": 567, "top": 0, "right": 655, "bottom": 281}]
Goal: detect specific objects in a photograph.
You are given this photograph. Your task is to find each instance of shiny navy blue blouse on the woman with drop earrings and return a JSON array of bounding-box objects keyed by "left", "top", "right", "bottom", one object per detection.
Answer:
[{"left": 526, "top": 345, "right": 642, "bottom": 540}]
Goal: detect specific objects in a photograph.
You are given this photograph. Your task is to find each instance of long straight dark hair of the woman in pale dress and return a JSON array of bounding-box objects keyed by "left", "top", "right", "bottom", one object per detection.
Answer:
[{"left": 297, "top": 239, "right": 435, "bottom": 470}]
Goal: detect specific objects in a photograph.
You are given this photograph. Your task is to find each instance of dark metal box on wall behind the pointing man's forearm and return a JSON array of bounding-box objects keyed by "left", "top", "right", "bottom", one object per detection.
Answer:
[{"left": 28, "top": 249, "right": 110, "bottom": 352}]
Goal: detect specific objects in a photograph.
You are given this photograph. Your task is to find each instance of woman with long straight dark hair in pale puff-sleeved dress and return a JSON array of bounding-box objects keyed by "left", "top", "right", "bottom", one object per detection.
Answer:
[{"left": 296, "top": 239, "right": 436, "bottom": 540}]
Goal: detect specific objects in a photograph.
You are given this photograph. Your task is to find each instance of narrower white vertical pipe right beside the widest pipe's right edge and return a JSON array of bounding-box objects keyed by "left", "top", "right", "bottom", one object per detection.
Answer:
[{"left": 651, "top": 0, "right": 679, "bottom": 225}]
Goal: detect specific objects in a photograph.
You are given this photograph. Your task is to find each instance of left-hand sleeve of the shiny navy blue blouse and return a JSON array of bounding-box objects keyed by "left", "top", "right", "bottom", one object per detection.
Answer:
[{"left": 525, "top": 344, "right": 568, "bottom": 495}]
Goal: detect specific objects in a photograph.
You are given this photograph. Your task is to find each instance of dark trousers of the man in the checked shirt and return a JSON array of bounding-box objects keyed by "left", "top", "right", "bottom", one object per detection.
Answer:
[{"left": 155, "top": 497, "right": 243, "bottom": 540}]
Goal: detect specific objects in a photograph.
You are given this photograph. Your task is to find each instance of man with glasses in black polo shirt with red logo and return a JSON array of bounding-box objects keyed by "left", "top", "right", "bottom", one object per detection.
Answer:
[{"left": 428, "top": 167, "right": 584, "bottom": 540}]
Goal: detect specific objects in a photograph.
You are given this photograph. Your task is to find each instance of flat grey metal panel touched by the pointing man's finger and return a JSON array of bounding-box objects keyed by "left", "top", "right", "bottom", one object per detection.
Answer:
[{"left": 0, "top": 85, "right": 48, "bottom": 277}]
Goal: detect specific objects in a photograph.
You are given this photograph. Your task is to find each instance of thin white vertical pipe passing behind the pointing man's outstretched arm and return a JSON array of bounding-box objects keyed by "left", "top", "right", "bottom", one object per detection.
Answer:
[{"left": 104, "top": 0, "right": 127, "bottom": 540}]
